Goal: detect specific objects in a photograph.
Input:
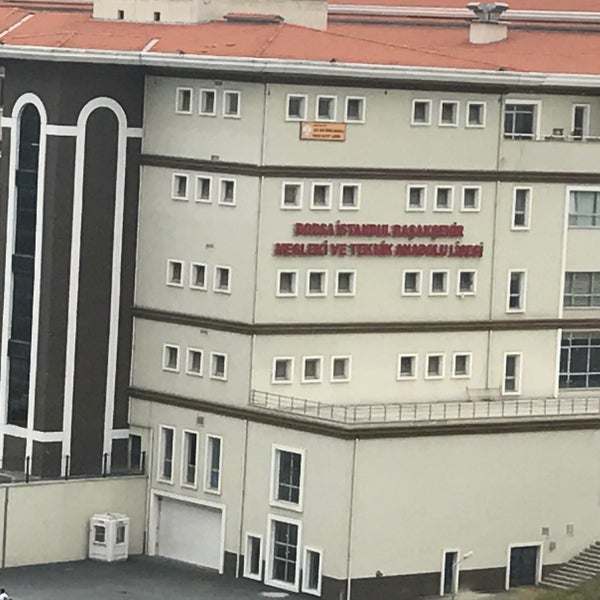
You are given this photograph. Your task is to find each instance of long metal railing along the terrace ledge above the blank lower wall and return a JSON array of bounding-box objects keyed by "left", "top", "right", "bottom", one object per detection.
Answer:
[{"left": 250, "top": 390, "right": 600, "bottom": 424}]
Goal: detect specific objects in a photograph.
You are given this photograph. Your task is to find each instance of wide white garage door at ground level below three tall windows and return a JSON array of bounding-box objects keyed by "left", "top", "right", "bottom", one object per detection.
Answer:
[{"left": 156, "top": 496, "right": 222, "bottom": 569}]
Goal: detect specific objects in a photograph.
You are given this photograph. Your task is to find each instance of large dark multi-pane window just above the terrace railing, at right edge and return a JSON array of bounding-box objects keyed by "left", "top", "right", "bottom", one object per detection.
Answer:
[{"left": 558, "top": 331, "right": 600, "bottom": 388}]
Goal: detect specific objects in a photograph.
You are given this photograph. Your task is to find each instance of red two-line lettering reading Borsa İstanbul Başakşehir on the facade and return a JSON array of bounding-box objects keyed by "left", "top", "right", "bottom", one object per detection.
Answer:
[{"left": 273, "top": 221, "right": 483, "bottom": 258}]
